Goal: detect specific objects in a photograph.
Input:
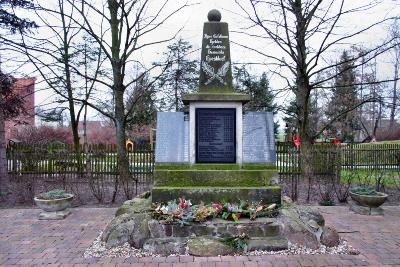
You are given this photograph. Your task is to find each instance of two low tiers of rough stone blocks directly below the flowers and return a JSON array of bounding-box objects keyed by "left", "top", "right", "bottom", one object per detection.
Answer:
[{"left": 143, "top": 218, "right": 288, "bottom": 256}]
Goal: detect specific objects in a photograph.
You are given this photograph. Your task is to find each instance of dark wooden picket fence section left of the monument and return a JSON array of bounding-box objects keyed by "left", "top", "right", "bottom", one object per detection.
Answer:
[{"left": 7, "top": 144, "right": 154, "bottom": 181}]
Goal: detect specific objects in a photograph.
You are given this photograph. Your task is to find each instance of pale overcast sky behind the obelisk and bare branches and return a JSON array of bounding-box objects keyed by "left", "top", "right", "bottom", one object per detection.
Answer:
[{"left": 3, "top": 0, "right": 400, "bottom": 125}]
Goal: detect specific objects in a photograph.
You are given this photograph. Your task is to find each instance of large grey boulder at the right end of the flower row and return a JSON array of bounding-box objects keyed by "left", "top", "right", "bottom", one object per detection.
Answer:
[{"left": 278, "top": 207, "right": 325, "bottom": 249}]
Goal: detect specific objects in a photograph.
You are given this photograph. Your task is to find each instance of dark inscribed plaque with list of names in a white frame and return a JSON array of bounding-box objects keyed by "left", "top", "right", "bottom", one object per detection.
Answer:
[{"left": 196, "top": 108, "right": 236, "bottom": 163}]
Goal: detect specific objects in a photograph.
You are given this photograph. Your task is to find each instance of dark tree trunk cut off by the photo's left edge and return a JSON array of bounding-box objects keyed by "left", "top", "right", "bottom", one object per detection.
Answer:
[{"left": 0, "top": 107, "right": 10, "bottom": 193}]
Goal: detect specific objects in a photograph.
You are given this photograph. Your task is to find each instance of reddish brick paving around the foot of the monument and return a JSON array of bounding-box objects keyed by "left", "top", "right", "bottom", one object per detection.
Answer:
[{"left": 0, "top": 207, "right": 400, "bottom": 267}]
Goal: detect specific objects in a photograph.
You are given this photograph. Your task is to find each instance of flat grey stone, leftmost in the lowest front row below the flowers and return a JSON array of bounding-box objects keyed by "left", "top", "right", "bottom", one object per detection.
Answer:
[{"left": 143, "top": 237, "right": 188, "bottom": 255}]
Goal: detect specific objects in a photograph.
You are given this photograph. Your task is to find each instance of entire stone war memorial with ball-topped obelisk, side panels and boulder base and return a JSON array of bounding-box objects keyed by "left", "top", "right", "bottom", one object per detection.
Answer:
[{"left": 101, "top": 10, "right": 339, "bottom": 256}]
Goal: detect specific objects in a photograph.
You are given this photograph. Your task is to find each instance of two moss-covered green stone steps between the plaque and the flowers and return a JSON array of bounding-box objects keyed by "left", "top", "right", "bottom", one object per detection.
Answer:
[{"left": 152, "top": 164, "right": 281, "bottom": 204}]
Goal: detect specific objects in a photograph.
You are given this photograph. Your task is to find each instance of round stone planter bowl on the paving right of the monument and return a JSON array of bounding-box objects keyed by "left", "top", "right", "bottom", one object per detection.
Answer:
[{"left": 349, "top": 188, "right": 388, "bottom": 215}]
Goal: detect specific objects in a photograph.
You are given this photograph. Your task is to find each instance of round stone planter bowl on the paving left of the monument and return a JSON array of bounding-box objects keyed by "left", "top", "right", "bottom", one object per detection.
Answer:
[{"left": 34, "top": 190, "right": 74, "bottom": 220}]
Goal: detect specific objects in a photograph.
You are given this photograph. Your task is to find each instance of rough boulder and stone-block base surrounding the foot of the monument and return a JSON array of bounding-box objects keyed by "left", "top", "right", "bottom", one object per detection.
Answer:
[{"left": 101, "top": 194, "right": 339, "bottom": 256}]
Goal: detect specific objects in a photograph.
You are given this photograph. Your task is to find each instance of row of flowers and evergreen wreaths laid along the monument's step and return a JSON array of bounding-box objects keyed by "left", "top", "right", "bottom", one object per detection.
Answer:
[{"left": 152, "top": 198, "right": 278, "bottom": 225}]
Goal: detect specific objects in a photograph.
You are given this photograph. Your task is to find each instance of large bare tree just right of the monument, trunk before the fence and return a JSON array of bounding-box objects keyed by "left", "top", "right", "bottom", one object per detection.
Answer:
[{"left": 235, "top": 0, "right": 393, "bottom": 197}]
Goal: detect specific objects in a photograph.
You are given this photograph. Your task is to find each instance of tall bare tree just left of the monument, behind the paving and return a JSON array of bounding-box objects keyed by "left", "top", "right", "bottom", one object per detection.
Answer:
[{"left": 62, "top": 0, "right": 187, "bottom": 201}]
